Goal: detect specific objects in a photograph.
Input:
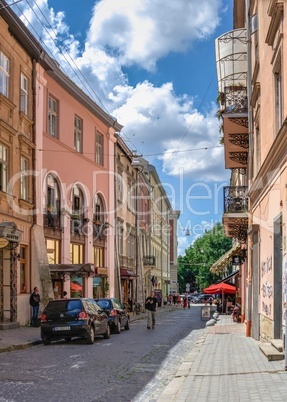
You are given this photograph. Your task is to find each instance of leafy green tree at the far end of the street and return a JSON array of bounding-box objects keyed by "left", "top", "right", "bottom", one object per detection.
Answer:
[{"left": 178, "top": 223, "right": 232, "bottom": 293}]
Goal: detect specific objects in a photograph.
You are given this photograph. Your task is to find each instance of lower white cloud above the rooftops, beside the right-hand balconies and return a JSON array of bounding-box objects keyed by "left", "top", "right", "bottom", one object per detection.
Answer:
[{"left": 110, "top": 82, "right": 226, "bottom": 181}]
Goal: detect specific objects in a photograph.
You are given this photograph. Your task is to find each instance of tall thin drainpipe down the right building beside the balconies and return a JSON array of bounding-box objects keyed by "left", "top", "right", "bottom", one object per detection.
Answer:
[{"left": 245, "top": 0, "right": 253, "bottom": 337}]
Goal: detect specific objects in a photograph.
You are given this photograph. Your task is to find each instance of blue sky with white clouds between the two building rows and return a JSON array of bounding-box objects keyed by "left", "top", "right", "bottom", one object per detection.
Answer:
[{"left": 10, "top": 0, "right": 233, "bottom": 255}]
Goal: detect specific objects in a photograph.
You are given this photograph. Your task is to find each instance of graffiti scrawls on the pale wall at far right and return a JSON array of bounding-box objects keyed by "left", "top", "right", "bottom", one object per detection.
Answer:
[{"left": 260, "top": 257, "right": 274, "bottom": 318}]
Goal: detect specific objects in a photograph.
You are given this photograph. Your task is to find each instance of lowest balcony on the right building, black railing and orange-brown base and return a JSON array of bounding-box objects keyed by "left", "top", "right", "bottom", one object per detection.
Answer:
[{"left": 222, "top": 186, "right": 249, "bottom": 242}]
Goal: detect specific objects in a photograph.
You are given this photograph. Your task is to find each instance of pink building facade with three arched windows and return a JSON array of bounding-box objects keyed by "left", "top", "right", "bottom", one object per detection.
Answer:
[{"left": 34, "top": 60, "right": 121, "bottom": 304}]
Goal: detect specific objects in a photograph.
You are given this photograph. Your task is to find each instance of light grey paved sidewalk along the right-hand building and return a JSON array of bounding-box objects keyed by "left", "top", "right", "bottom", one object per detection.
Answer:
[{"left": 157, "top": 315, "right": 287, "bottom": 402}]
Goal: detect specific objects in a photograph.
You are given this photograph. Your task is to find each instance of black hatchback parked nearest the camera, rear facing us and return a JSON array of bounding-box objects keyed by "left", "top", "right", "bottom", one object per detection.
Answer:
[{"left": 41, "top": 298, "right": 110, "bottom": 345}]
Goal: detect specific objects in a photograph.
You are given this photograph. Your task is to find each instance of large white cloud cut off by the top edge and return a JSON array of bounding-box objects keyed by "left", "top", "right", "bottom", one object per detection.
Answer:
[{"left": 88, "top": 0, "right": 222, "bottom": 70}]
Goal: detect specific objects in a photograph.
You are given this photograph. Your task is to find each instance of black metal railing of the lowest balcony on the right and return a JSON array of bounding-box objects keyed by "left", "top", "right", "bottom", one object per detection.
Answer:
[{"left": 223, "top": 186, "right": 248, "bottom": 213}]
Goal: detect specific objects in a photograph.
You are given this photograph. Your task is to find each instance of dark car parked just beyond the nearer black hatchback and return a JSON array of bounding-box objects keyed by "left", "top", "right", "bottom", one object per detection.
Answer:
[{"left": 95, "top": 298, "right": 130, "bottom": 334}]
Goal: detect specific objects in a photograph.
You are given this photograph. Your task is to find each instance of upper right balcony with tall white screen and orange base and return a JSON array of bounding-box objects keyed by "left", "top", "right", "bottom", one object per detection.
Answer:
[{"left": 215, "top": 29, "right": 249, "bottom": 169}]
